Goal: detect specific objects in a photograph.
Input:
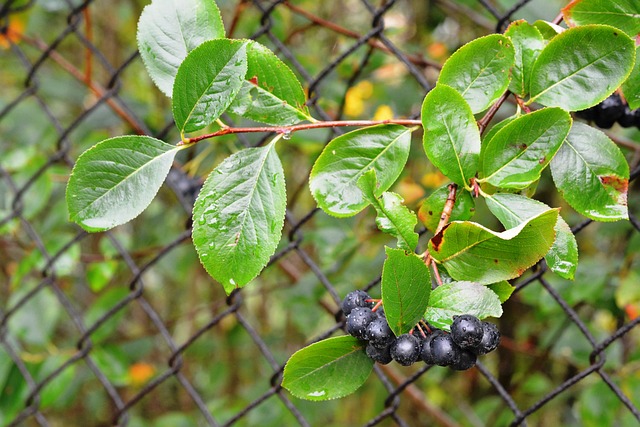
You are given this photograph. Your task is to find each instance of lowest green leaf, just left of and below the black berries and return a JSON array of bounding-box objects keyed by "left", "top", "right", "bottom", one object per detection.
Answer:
[{"left": 282, "top": 336, "right": 373, "bottom": 400}]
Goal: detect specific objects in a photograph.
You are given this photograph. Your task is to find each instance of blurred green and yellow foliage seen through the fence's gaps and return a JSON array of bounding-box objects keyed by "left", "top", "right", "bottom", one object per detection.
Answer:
[{"left": 0, "top": 0, "right": 640, "bottom": 427}]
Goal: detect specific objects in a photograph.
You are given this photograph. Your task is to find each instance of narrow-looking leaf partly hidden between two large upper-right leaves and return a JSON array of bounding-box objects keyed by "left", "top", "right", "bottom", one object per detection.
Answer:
[{"left": 504, "top": 19, "right": 545, "bottom": 98}]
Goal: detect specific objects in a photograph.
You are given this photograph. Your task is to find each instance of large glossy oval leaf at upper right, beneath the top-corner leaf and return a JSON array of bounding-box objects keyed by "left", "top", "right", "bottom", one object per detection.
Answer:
[{"left": 529, "top": 25, "right": 635, "bottom": 111}]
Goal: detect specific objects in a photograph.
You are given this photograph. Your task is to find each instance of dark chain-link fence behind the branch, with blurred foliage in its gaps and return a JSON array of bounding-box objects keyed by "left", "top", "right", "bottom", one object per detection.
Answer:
[{"left": 0, "top": 0, "right": 640, "bottom": 426}]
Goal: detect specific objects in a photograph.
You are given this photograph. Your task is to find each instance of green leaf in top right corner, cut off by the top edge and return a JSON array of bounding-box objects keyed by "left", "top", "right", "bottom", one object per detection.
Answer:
[{"left": 562, "top": 0, "right": 640, "bottom": 38}]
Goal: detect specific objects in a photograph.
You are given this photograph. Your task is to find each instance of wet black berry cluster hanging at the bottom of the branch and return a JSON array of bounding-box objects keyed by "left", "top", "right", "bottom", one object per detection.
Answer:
[{"left": 342, "top": 291, "right": 500, "bottom": 371}]
